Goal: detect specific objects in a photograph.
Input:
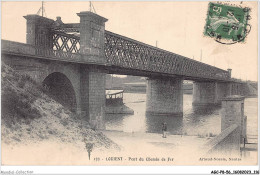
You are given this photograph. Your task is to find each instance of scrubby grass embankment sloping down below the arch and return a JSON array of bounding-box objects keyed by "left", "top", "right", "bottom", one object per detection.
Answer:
[{"left": 1, "top": 63, "right": 118, "bottom": 150}]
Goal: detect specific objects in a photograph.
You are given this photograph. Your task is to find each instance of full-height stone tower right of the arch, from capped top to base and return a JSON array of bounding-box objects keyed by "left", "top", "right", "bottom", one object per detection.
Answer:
[{"left": 78, "top": 12, "right": 107, "bottom": 129}]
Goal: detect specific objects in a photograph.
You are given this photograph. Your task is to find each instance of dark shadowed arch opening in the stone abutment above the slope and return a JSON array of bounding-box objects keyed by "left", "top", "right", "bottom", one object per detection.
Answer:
[{"left": 42, "top": 72, "right": 77, "bottom": 112}]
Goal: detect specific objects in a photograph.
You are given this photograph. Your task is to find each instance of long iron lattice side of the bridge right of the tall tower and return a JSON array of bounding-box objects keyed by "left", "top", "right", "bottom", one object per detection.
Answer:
[{"left": 105, "top": 31, "right": 229, "bottom": 80}]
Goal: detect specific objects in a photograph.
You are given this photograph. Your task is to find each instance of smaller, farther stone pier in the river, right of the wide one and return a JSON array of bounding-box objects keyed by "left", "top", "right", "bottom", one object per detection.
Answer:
[{"left": 192, "top": 82, "right": 220, "bottom": 106}]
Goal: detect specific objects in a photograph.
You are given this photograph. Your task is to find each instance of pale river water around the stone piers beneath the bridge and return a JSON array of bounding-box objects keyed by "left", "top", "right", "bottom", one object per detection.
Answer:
[{"left": 105, "top": 93, "right": 258, "bottom": 136}]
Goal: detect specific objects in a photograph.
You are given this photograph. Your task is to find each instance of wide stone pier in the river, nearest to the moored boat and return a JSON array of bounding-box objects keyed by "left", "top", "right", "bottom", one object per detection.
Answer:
[{"left": 146, "top": 78, "right": 183, "bottom": 116}]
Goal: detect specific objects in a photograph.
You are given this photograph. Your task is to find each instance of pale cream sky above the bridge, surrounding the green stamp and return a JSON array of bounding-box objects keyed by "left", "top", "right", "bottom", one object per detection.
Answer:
[{"left": 1, "top": 1, "right": 258, "bottom": 81}]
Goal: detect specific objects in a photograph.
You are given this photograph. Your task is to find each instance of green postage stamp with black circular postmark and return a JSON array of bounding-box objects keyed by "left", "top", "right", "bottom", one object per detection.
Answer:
[{"left": 204, "top": 2, "right": 251, "bottom": 44}]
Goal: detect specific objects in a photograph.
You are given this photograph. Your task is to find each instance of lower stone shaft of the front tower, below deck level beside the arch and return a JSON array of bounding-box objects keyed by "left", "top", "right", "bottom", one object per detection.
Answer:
[{"left": 80, "top": 66, "right": 106, "bottom": 129}]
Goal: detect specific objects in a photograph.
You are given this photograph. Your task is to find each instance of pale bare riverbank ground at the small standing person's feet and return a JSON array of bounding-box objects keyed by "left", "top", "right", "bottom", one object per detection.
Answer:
[{"left": 103, "top": 131, "right": 208, "bottom": 165}]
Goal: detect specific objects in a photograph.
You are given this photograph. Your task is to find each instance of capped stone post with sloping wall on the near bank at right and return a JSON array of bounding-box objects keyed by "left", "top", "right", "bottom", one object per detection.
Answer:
[{"left": 202, "top": 95, "right": 246, "bottom": 158}]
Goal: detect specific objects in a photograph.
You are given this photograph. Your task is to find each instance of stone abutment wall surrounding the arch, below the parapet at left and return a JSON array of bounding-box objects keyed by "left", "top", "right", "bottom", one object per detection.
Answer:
[{"left": 2, "top": 54, "right": 81, "bottom": 113}]
